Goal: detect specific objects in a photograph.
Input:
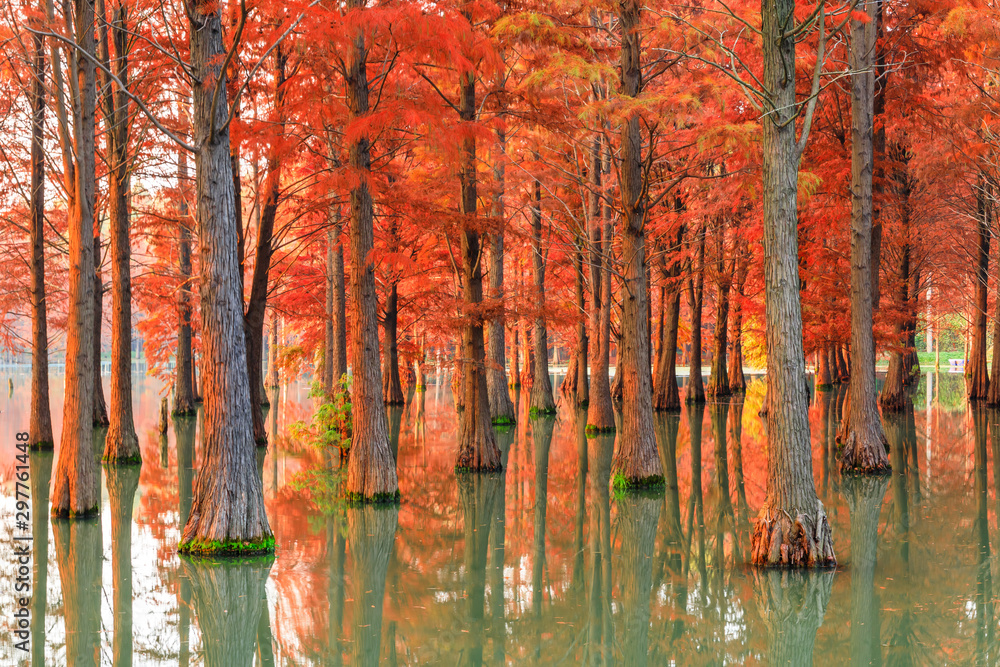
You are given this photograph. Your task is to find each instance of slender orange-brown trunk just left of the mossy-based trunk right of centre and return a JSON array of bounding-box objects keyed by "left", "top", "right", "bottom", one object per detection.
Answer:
[{"left": 587, "top": 135, "right": 615, "bottom": 431}]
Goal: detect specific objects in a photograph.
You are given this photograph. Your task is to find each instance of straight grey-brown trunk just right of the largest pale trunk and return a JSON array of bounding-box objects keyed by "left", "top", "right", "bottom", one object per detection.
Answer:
[{"left": 839, "top": 3, "right": 889, "bottom": 473}]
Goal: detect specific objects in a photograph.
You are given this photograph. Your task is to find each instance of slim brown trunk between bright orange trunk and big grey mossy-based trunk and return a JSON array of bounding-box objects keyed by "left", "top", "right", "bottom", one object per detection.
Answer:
[{"left": 98, "top": 0, "right": 142, "bottom": 464}]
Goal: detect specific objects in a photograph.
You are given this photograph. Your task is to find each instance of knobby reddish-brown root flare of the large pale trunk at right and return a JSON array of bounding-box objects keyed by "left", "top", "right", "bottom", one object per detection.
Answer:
[{"left": 750, "top": 502, "right": 837, "bottom": 568}]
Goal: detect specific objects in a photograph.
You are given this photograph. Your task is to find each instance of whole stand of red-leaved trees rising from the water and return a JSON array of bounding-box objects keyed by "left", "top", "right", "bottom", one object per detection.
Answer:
[{"left": 0, "top": 0, "right": 1000, "bottom": 565}]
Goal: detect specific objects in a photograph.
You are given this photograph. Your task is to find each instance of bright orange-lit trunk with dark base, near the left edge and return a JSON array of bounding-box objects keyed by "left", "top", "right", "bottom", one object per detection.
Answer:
[{"left": 49, "top": 0, "right": 101, "bottom": 516}]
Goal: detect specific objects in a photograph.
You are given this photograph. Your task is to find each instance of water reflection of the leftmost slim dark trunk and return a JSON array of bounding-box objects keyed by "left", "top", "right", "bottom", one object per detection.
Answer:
[{"left": 29, "top": 451, "right": 53, "bottom": 667}]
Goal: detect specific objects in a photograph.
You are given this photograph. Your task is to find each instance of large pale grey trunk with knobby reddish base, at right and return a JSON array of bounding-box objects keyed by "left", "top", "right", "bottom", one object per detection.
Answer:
[{"left": 750, "top": 0, "right": 836, "bottom": 568}]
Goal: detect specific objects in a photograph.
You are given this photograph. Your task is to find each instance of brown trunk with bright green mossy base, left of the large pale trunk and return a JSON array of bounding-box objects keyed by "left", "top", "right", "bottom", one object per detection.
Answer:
[{"left": 607, "top": 0, "right": 663, "bottom": 488}]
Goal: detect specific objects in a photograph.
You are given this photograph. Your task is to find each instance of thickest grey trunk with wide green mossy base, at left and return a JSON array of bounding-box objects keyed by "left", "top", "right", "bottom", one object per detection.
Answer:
[{"left": 178, "top": 0, "right": 274, "bottom": 552}]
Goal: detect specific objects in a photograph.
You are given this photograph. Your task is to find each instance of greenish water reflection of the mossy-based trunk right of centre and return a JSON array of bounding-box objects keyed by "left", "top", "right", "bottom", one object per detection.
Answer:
[{"left": 617, "top": 495, "right": 662, "bottom": 667}]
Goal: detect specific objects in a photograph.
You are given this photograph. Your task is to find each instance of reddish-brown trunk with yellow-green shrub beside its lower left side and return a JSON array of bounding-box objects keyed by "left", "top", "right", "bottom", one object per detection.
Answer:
[{"left": 346, "top": 0, "right": 399, "bottom": 502}]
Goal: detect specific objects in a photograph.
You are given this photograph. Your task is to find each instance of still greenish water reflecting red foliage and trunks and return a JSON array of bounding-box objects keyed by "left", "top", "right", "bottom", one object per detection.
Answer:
[{"left": 0, "top": 374, "right": 1000, "bottom": 666}]
